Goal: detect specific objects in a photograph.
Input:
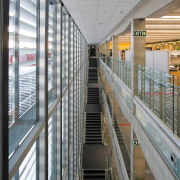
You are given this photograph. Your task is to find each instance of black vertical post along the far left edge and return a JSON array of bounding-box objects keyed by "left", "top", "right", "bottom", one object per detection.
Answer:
[{"left": 0, "top": 0, "right": 9, "bottom": 179}]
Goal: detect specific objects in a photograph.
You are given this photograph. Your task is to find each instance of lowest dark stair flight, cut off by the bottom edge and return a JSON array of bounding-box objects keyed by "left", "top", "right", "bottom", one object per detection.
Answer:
[{"left": 83, "top": 169, "right": 105, "bottom": 180}]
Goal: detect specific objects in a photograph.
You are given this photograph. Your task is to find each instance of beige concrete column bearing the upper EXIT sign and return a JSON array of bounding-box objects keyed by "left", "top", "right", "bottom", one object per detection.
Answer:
[{"left": 130, "top": 19, "right": 146, "bottom": 180}]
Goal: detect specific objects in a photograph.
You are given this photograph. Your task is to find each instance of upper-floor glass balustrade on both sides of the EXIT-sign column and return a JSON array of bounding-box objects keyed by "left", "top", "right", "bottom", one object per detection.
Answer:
[{"left": 100, "top": 57, "right": 180, "bottom": 137}]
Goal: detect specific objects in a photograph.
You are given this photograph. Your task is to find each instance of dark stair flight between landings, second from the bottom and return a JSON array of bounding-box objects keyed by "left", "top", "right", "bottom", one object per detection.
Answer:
[{"left": 86, "top": 113, "right": 102, "bottom": 144}]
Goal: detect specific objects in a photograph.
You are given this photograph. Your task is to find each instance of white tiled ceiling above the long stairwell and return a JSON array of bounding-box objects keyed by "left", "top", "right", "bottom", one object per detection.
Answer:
[{"left": 62, "top": 0, "right": 140, "bottom": 44}]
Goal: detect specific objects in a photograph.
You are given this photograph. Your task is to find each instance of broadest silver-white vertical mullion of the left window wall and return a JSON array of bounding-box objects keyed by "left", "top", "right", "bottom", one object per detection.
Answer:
[{"left": 39, "top": 0, "right": 49, "bottom": 180}]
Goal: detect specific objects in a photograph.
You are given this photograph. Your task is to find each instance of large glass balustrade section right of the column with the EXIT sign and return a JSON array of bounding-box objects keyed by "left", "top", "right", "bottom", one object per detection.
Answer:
[{"left": 137, "top": 65, "right": 180, "bottom": 136}]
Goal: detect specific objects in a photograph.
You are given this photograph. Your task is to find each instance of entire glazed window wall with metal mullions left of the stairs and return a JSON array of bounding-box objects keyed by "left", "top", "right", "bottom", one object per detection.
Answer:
[{"left": 0, "top": 0, "right": 88, "bottom": 180}]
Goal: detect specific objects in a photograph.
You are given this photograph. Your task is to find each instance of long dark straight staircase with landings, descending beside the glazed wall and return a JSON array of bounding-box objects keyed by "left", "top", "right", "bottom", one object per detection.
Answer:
[{"left": 83, "top": 45, "right": 106, "bottom": 180}]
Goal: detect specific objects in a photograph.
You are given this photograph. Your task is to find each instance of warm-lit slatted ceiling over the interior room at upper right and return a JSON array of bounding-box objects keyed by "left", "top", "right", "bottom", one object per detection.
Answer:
[{"left": 119, "top": 9, "right": 180, "bottom": 43}]
